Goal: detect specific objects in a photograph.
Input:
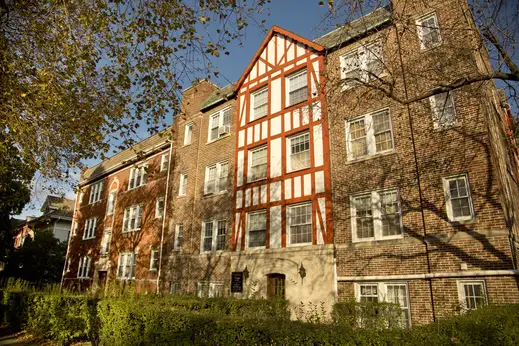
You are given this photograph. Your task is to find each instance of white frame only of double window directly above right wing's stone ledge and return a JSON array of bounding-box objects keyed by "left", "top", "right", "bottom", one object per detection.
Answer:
[{"left": 350, "top": 189, "right": 404, "bottom": 243}]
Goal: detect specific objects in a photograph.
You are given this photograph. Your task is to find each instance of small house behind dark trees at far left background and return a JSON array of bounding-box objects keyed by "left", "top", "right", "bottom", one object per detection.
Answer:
[{"left": 14, "top": 196, "right": 74, "bottom": 248}]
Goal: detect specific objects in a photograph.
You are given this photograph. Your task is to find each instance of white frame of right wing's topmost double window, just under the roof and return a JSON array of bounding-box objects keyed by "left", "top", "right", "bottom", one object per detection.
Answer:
[{"left": 339, "top": 40, "right": 386, "bottom": 91}]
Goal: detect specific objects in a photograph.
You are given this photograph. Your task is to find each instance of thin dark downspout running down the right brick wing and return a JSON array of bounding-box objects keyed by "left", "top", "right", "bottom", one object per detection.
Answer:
[{"left": 393, "top": 19, "right": 436, "bottom": 322}]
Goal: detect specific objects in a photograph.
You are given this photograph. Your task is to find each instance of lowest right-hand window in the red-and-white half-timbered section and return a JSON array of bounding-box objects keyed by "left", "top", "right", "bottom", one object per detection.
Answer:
[{"left": 287, "top": 203, "right": 312, "bottom": 245}]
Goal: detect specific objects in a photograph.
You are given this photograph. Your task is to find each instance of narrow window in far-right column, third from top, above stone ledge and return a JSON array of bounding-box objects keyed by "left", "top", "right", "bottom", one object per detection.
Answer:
[{"left": 443, "top": 174, "right": 474, "bottom": 221}]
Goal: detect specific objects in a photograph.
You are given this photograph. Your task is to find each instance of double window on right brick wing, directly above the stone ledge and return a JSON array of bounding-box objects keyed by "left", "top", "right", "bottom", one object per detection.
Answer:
[{"left": 351, "top": 190, "right": 402, "bottom": 241}]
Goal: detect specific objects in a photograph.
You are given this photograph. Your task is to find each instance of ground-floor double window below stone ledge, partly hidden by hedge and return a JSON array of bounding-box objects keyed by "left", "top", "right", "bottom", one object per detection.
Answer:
[{"left": 356, "top": 282, "right": 411, "bottom": 327}]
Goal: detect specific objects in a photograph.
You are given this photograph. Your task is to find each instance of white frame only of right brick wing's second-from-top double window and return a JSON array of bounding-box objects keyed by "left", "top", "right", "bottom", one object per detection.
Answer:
[{"left": 346, "top": 108, "right": 395, "bottom": 161}]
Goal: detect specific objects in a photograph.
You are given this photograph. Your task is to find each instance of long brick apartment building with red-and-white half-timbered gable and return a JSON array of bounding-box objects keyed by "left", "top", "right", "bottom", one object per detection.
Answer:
[{"left": 63, "top": 0, "right": 519, "bottom": 325}]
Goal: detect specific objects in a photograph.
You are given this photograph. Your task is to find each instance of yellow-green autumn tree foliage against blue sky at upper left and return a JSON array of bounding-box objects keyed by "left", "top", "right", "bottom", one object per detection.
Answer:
[{"left": 0, "top": 0, "right": 269, "bottom": 187}]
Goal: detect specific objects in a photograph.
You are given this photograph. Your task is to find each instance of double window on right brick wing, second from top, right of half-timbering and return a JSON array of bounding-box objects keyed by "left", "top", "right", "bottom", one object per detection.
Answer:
[{"left": 346, "top": 109, "right": 395, "bottom": 161}]
